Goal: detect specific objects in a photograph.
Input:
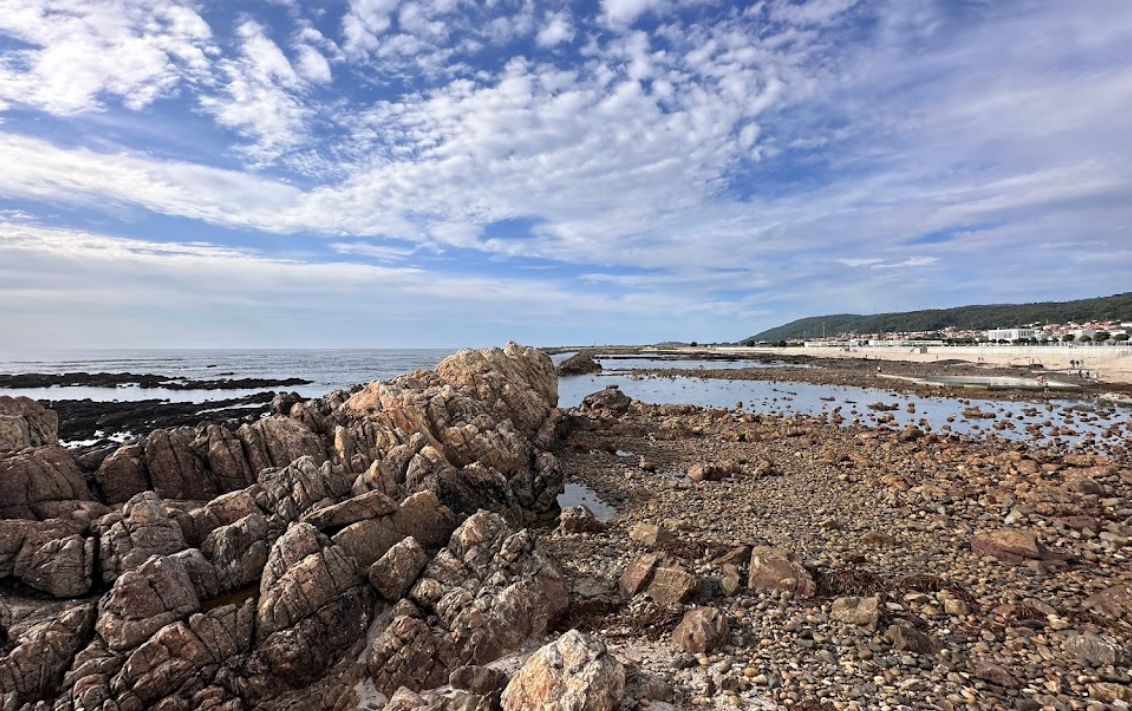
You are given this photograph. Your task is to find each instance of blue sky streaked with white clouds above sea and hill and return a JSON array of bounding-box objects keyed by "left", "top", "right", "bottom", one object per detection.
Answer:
[{"left": 0, "top": 0, "right": 1132, "bottom": 350}]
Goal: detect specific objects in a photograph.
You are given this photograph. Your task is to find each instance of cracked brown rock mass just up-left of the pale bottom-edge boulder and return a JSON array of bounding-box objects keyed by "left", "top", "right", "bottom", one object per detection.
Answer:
[{"left": 367, "top": 512, "right": 568, "bottom": 694}]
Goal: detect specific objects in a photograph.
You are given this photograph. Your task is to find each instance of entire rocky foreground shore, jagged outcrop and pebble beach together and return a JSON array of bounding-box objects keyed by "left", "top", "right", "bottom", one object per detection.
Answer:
[{"left": 0, "top": 344, "right": 1132, "bottom": 711}]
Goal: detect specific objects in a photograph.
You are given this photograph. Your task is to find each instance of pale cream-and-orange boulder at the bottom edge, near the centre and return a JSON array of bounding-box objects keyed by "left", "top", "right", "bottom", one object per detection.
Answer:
[{"left": 503, "top": 629, "right": 625, "bottom": 711}]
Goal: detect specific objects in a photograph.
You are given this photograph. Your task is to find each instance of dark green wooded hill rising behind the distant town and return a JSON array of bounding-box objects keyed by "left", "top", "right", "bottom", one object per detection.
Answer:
[{"left": 743, "top": 292, "right": 1132, "bottom": 344}]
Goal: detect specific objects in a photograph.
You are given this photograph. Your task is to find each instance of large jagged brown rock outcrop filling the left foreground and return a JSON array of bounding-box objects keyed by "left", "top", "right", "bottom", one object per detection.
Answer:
[{"left": 0, "top": 343, "right": 570, "bottom": 711}]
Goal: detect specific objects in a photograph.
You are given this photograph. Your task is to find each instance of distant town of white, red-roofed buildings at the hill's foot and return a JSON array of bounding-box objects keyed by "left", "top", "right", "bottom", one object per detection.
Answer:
[{"left": 787, "top": 320, "right": 1132, "bottom": 348}]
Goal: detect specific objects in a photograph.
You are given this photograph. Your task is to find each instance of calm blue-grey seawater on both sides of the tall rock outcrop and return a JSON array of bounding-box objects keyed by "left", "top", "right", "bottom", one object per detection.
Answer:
[{"left": 0, "top": 349, "right": 1129, "bottom": 442}]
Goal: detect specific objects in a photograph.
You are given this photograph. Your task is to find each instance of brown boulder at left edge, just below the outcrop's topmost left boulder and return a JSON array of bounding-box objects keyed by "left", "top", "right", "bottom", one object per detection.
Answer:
[{"left": 0, "top": 445, "right": 94, "bottom": 520}]
